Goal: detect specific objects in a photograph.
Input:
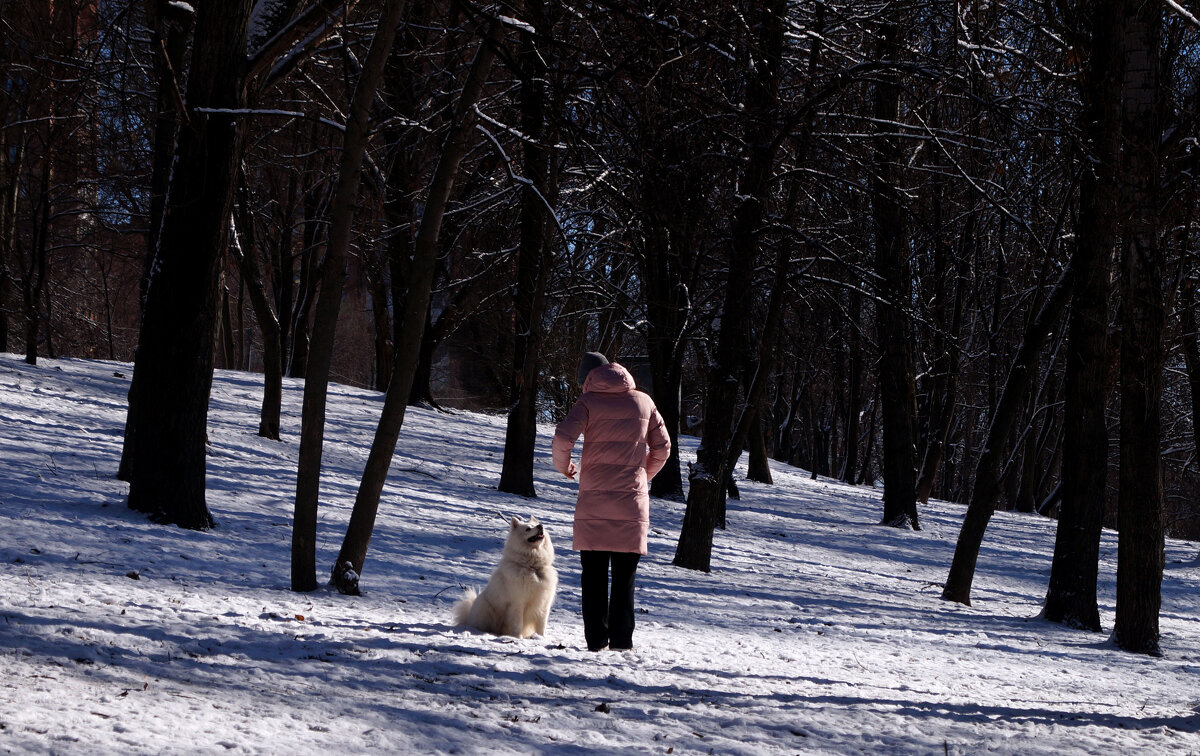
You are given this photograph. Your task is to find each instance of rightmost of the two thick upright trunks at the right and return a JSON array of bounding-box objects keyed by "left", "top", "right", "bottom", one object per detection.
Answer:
[{"left": 1112, "top": 2, "right": 1166, "bottom": 656}]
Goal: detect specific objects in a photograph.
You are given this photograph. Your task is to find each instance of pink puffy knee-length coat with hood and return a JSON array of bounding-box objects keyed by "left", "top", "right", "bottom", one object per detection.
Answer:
[{"left": 552, "top": 362, "right": 671, "bottom": 554}]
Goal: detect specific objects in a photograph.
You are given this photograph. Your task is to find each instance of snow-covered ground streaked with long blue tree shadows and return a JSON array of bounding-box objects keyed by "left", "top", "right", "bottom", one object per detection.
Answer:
[{"left": 0, "top": 355, "right": 1200, "bottom": 756}]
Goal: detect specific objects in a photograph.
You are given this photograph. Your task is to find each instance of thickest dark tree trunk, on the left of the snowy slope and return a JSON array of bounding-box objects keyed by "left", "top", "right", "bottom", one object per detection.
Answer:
[{"left": 128, "top": 0, "right": 250, "bottom": 529}]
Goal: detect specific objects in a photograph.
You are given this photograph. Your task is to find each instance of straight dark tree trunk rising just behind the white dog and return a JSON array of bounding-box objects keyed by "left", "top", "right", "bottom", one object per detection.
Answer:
[{"left": 499, "top": 0, "right": 551, "bottom": 497}]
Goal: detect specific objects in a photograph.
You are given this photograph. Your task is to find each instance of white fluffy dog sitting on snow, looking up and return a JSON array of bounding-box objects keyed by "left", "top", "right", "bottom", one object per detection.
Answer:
[{"left": 454, "top": 517, "right": 558, "bottom": 638}]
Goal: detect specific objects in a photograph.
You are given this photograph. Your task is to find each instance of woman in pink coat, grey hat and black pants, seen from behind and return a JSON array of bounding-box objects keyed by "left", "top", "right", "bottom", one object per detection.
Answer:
[{"left": 552, "top": 352, "right": 671, "bottom": 650}]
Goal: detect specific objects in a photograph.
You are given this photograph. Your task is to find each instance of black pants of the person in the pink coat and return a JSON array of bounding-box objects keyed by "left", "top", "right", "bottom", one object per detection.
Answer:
[{"left": 580, "top": 551, "right": 641, "bottom": 650}]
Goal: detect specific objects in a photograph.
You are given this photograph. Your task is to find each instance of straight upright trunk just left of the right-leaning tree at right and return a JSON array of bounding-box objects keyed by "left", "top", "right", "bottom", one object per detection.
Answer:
[{"left": 871, "top": 24, "right": 920, "bottom": 530}]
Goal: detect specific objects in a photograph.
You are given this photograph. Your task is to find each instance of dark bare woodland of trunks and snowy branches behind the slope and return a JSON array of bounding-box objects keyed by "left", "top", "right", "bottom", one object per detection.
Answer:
[{"left": 0, "top": 0, "right": 1200, "bottom": 653}]
